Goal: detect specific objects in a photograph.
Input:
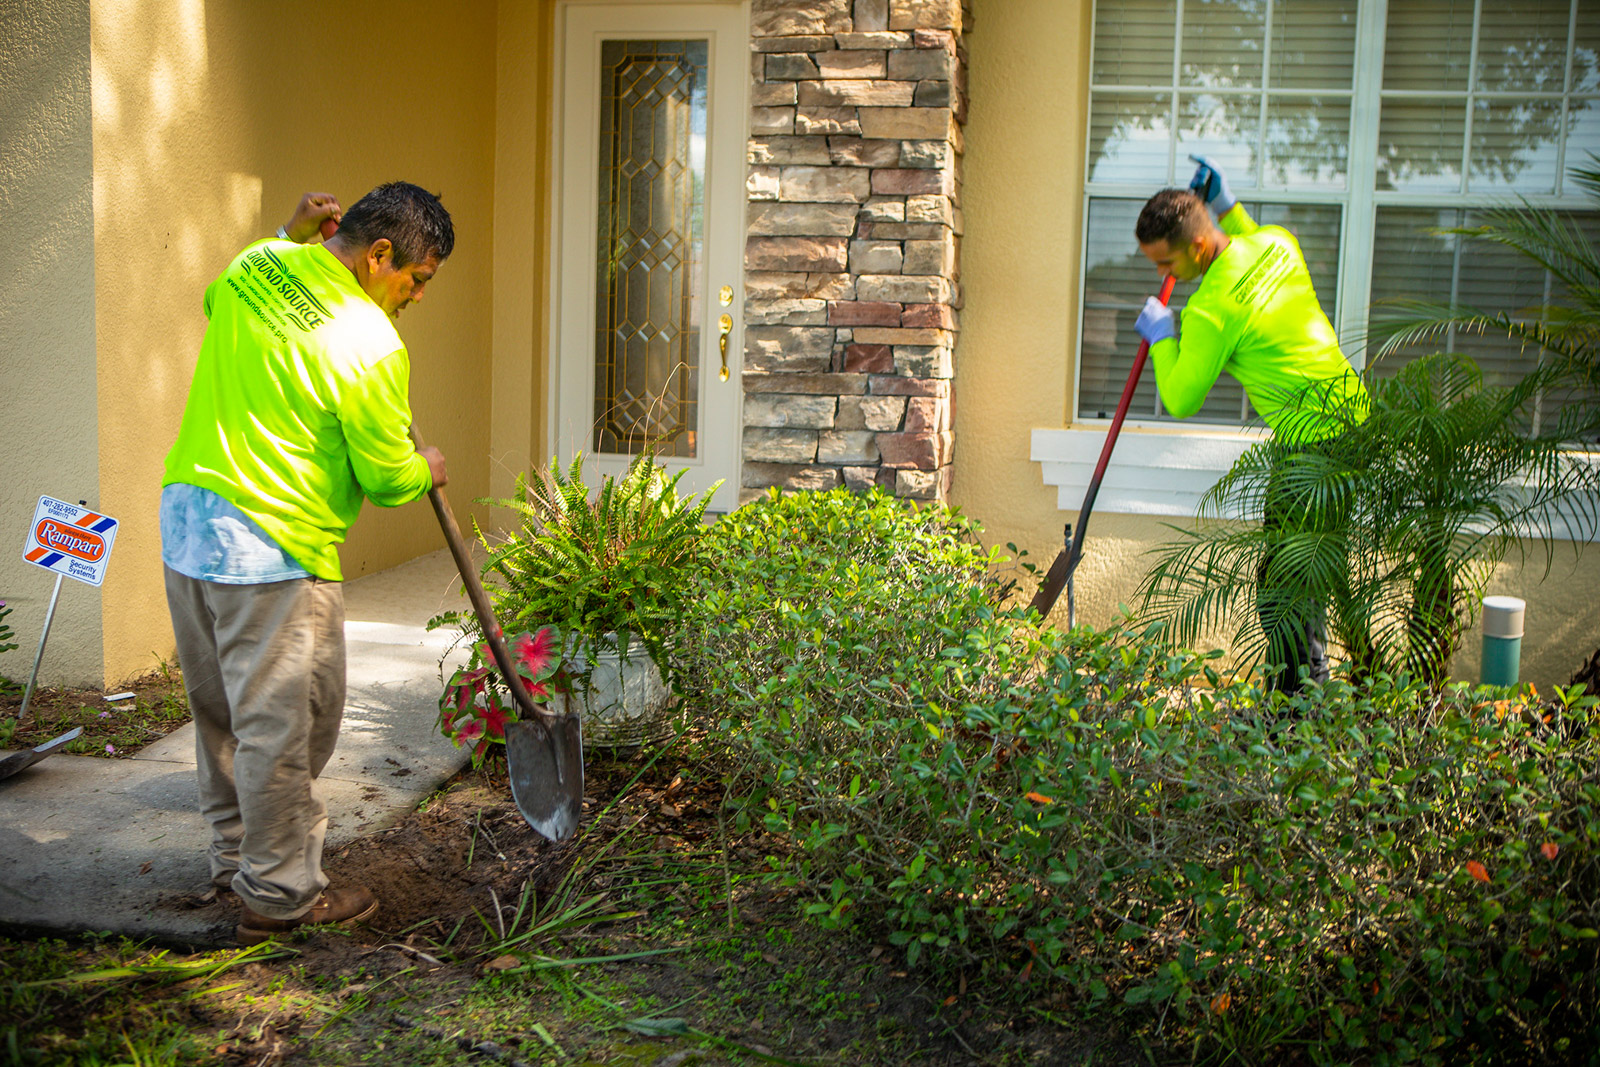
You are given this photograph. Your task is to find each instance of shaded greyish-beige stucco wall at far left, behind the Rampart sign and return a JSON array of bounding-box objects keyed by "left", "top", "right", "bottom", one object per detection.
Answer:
[{"left": 0, "top": 0, "right": 103, "bottom": 681}]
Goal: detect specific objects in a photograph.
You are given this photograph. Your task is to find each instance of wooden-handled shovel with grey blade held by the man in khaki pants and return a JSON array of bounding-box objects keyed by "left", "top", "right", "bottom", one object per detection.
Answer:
[{"left": 411, "top": 427, "right": 584, "bottom": 841}]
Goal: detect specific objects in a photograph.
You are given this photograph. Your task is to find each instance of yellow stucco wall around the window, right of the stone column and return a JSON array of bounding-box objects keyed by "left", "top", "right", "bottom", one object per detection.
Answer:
[{"left": 954, "top": 0, "right": 1600, "bottom": 685}]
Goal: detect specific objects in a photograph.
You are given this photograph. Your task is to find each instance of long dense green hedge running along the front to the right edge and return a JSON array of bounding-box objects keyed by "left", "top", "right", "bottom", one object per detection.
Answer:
[{"left": 682, "top": 493, "right": 1600, "bottom": 1064}]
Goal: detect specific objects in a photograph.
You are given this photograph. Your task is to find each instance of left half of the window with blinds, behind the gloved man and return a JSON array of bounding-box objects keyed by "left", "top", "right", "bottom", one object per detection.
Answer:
[{"left": 1077, "top": 0, "right": 1357, "bottom": 426}]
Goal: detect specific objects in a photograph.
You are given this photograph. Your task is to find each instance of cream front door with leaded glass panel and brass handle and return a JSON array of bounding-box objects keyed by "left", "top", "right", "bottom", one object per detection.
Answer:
[{"left": 554, "top": 3, "right": 749, "bottom": 512}]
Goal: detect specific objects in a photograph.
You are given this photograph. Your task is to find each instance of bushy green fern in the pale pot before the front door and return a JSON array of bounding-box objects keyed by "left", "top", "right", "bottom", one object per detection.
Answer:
[{"left": 461, "top": 453, "right": 717, "bottom": 670}]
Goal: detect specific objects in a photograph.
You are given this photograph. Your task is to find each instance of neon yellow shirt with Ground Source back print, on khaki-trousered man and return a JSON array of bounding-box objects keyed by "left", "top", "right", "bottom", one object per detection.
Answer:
[{"left": 162, "top": 240, "right": 432, "bottom": 581}]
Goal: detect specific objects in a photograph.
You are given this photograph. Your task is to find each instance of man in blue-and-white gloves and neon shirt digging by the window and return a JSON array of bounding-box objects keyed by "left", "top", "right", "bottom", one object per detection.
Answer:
[{"left": 1134, "top": 157, "right": 1366, "bottom": 691}]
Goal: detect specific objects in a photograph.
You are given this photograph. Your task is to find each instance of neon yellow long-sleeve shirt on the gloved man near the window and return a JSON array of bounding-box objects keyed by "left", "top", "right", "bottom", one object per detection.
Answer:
[{"left": 1150, "top": 205, "right": 1366, "bottom": 443}]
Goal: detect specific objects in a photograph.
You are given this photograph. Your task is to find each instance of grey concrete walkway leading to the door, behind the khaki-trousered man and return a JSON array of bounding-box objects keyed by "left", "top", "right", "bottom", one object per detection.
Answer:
[{"left": 0, "top": 550, "right": 467, "bottom": 945}]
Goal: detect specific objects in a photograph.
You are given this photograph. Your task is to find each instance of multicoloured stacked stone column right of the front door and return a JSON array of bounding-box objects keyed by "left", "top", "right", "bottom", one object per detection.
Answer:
[{"left": 744, "top": 0, "right": 971, "bottom": 499}]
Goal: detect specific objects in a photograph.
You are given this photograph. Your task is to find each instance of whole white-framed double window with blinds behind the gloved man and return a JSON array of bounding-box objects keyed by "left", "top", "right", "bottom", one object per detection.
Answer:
[{"left": 1077, "top": 0, "right": 1600, "bottom": 426}]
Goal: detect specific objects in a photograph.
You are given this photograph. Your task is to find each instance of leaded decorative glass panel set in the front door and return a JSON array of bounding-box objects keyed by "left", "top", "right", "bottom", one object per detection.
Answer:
[{"left": 595, "top": 40, "right": 706, "bottom": 458}]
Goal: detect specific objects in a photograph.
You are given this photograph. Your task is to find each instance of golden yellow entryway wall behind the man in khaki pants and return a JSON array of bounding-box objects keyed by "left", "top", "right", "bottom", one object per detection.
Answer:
[{"left": 91, "top": 0, "right": 496, "bottom": 681}]
